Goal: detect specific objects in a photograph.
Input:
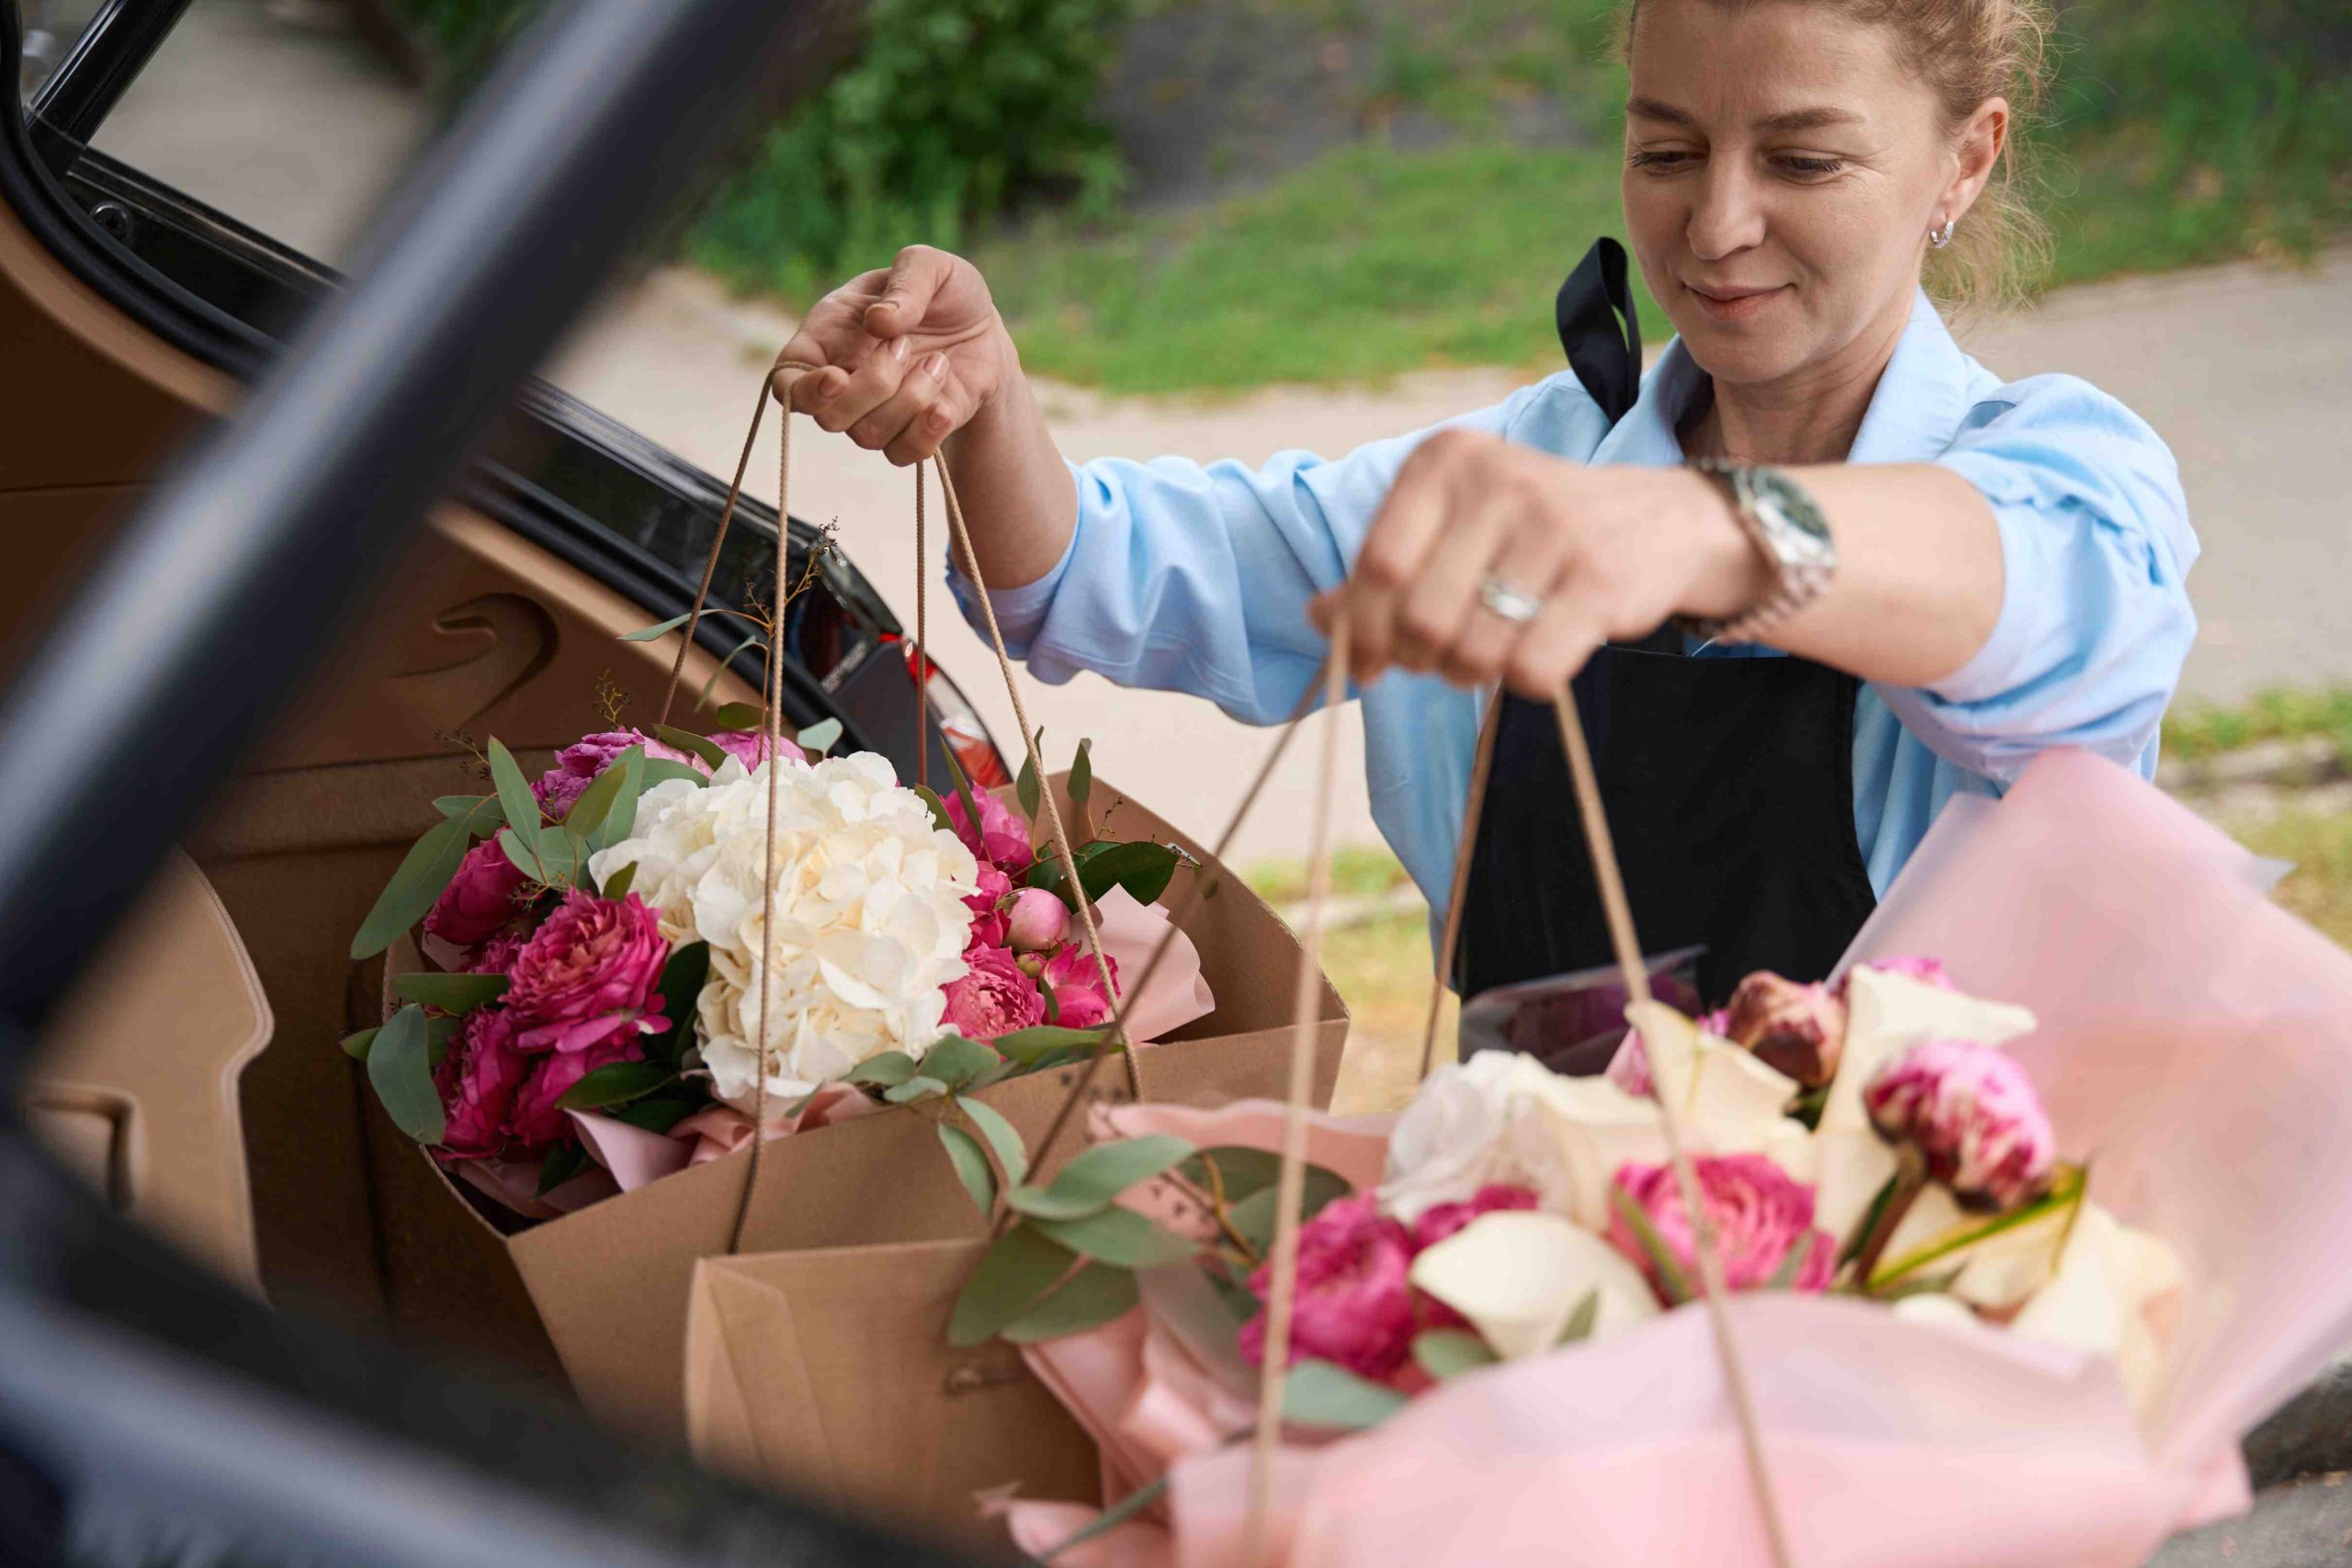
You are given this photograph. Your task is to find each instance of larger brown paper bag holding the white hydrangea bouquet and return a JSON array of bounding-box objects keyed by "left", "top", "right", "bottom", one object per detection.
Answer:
[{"left": 371, "top": 778, "right": 1348, "bottom": 1438}]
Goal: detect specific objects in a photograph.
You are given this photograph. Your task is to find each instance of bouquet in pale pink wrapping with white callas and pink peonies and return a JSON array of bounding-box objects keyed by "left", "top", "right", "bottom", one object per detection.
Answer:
[{"left": 922, "top": 755, "right": 2352, "bottom": 1568}]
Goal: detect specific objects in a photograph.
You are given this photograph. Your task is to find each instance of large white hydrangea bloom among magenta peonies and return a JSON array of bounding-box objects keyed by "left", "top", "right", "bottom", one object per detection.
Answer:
[{"left": 588, "top": 752, "right": 978, "bottom": 1110}]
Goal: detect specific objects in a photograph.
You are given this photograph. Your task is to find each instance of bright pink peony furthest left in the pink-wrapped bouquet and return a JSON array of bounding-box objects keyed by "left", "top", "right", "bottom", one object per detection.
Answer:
[{"left": 1239, "top": 1197, "right": 1419, "bottom": 1380}]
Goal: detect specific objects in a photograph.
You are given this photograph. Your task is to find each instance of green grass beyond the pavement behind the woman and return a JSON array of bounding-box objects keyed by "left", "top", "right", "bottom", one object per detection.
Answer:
[{"left": 945, "top": 0, "right": 2352, "bottom": 392}]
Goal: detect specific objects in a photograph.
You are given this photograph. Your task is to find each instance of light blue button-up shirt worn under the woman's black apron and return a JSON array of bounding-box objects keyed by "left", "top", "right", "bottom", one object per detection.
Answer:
[{"left": 950, "top": 294, "right": 2197, "bottom": 909}]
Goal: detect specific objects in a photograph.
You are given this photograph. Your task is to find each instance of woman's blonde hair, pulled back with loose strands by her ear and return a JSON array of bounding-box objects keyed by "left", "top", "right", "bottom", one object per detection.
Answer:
[{"left": 1623, "top": 0, "right": 2051, "bottom": 310}]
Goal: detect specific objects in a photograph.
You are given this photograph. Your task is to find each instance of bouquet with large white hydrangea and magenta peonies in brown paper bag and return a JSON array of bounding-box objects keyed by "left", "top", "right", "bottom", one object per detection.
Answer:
[{"left": 345, "top": 707, "right": 1343, "bottom": 1429}]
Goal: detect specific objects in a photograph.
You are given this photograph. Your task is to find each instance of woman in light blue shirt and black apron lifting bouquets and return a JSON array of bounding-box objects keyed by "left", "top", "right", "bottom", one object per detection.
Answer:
[{"left": 786, "top": 0, "right": 2197, "bottom": 997}]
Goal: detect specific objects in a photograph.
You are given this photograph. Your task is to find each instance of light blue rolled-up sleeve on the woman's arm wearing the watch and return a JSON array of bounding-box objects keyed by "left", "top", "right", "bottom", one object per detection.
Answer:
[{"left": 1882, "top": 376, "right": 2197, "bottom": 785}]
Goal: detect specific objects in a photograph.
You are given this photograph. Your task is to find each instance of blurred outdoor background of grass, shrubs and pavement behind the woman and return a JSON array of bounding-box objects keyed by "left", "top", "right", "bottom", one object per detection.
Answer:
[{"left": 24, "top": 0, "right": 2352, "bottom": 1098}]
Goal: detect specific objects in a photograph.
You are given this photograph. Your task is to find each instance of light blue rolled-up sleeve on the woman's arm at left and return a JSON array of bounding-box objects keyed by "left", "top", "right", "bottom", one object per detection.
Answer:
[{"left": 948, "top": 392, "right": 1529, "bottom": 724}]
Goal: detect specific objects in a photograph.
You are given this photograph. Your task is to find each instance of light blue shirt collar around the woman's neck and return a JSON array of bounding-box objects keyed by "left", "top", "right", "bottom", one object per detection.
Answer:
[{"left": 1592, "top": 289, "right": 1973, "bottom": 468}]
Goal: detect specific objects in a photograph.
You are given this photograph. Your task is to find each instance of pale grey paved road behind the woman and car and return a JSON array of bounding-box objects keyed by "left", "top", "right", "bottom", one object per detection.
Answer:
[{"left": 99, "top": 0, "right": 2352, "bottom": 863}]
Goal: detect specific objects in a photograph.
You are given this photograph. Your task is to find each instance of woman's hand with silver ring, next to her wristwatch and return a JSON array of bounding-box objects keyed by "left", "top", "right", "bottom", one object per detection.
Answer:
[{"left": 1310, "top": 430, "right": 1771, "bottom": 701}]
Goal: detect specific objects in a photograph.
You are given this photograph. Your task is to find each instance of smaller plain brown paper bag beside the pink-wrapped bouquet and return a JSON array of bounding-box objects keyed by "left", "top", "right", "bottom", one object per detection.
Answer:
[{"left": 687, "top": 1241, "right": 1101, "bottom": 1550}]
